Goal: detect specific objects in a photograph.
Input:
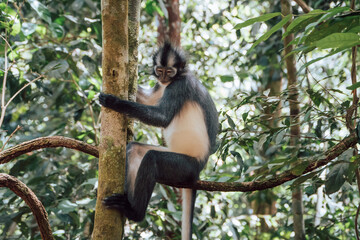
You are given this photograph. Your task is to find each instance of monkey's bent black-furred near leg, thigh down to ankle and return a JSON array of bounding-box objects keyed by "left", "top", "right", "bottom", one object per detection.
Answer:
[{"left": 127, "top": 150, "right": 201, "bottom": 221}]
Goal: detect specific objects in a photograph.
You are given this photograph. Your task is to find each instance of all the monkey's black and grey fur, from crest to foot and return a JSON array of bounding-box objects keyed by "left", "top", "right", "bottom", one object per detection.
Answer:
[{"left": 99, "top": 43, "right": 218, "bottom": 234}]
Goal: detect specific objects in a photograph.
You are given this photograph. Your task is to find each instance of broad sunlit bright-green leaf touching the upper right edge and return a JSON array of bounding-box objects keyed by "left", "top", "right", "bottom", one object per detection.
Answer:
[{"left": 315, "top": 33, "right": 360, "bottom": 49}]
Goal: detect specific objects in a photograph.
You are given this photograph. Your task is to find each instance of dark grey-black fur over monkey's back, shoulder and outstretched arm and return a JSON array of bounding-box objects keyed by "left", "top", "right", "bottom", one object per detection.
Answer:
[{"left": 99, "top": 73, "right": 218, "bottom": 153}]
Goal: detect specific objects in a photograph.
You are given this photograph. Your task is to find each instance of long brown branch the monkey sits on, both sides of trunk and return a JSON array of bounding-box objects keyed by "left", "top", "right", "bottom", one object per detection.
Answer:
[{"left": 0, "top": 132, "right": 358, "bottom": 192}]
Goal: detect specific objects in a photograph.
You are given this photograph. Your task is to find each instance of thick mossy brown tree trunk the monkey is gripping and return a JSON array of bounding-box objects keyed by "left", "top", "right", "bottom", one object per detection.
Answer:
[{"left": 93, "top": 0, "right": 129, "bottom": 237}]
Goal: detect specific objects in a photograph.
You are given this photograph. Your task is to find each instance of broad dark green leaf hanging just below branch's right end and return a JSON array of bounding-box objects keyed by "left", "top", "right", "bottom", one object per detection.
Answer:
[{"left": 325, "top": 163, "right": 349, "bottom": 194}]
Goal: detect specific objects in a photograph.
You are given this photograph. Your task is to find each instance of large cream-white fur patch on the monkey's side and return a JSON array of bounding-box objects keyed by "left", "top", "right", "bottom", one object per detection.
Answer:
[{"left": 164, "top": 101, "right": 209, "bottom": 159}]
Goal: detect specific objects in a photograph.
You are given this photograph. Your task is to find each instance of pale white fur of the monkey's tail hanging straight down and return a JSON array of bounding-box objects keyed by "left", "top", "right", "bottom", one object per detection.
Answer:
[{"left": 181, "top": 188, "right": 192, "bottom": 240}]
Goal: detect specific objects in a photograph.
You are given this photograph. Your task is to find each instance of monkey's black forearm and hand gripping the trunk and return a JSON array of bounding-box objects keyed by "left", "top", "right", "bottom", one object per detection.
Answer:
[{"left": 99, "top": 93, "right": 173, "bottom": 127}]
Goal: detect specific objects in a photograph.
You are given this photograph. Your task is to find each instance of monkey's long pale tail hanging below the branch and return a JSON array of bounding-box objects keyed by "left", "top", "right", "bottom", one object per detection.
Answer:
[{"left": 181, "top": 188, "right": 196, "bottom": 240}]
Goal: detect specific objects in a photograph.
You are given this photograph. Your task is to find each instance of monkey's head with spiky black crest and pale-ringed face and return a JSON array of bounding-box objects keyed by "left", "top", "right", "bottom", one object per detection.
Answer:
[{"left": 153, "top": 42, "right": 186, "bottom": 85}]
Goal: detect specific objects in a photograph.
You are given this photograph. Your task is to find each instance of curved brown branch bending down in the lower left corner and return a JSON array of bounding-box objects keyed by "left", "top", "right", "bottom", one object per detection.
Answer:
[{"left": 0, "top": 173, "right": 54, "bottom": 240}]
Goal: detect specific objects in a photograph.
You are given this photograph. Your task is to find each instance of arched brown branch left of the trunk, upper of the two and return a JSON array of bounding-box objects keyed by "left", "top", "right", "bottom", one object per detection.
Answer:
[{"left": 0, "top": 136, "right": 99, "bottom": 164}]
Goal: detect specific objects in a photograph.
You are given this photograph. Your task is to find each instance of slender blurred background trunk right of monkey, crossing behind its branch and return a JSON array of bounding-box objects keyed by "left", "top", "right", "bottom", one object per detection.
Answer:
[{"left": 281, "top": 0, "right": 305, "bottom": 240}]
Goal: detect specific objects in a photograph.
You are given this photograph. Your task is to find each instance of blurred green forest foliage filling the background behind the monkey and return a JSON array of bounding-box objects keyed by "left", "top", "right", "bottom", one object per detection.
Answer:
[{"left": 0, "top": 0, "right": 360, "bottom": 239}]
